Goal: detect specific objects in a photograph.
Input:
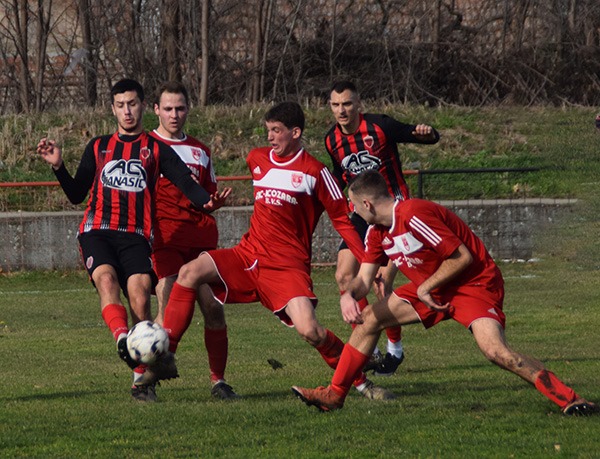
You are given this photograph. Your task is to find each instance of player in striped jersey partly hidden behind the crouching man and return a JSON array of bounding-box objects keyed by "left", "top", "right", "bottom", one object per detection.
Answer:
[{"left": 325, "top": 81, "right": 440, "bottom": 376}]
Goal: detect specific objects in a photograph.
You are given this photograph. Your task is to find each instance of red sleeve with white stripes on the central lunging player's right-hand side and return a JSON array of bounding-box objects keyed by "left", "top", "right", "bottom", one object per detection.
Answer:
[{"left": 316, "top": 166, "right": 364, "bottom": 262}]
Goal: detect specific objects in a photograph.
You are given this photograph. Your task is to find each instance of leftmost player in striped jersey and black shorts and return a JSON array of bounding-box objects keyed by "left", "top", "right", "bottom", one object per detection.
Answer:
[{"left": 37, "top": 79, "right": 213, "bottom": 401}]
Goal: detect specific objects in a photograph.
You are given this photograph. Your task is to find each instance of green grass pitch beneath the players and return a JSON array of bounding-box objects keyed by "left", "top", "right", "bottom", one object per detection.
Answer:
[{"left": 0, "top": 260, "right": 600, "bottom": 458}]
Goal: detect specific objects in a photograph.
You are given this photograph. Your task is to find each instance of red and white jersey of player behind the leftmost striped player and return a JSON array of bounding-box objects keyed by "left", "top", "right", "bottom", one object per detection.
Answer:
[{"left": 150, "top": 131, "right": 218, "bottom": 247}]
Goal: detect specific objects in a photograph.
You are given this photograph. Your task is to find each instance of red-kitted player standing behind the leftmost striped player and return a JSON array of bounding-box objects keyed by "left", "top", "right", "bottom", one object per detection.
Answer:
[{"left": 151, "top": 82, "right": 237, "bottom": 399}]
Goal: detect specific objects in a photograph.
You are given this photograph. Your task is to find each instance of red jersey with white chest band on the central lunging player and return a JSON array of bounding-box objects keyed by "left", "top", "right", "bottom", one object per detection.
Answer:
[{"left": 239, "top": 147, "right": 363, "bottom": 271}]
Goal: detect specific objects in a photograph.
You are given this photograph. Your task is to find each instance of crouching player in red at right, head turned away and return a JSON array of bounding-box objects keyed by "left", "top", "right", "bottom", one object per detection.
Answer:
[{"left": 292, "top": 171, "right": 600, "bottom": 415}]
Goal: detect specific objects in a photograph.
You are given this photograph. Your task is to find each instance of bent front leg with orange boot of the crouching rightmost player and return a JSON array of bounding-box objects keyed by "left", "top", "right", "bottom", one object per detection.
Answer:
[{"left": 292, "top": 294, "right": 419, "bottom": 411}]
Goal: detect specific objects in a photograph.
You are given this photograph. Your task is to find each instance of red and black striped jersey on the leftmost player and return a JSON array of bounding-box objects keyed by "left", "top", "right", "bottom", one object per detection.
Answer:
[{"left": 55, "top": 132, "right": 209, "bottom": 240}]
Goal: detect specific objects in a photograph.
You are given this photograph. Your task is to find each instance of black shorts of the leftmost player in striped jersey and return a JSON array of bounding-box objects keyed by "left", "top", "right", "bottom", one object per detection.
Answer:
[{"left": 77, "top": 230, "right": 157, "bottom": 294}]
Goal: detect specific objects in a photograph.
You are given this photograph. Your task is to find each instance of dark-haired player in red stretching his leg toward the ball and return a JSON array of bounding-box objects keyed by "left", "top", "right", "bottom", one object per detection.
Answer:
[{"left": 146, "top": 102, "right": 394, "bottom": 399}]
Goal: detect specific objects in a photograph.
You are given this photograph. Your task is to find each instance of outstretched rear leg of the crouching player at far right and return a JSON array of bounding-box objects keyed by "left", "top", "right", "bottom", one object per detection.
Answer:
[{"left": 471, "top": 318, "right": 600, "bottom": 415}]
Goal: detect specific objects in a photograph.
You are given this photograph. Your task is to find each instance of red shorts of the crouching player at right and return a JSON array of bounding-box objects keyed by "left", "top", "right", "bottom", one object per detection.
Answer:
[{"left": 394, "top": 283, "right": 506, "bottom": 329}]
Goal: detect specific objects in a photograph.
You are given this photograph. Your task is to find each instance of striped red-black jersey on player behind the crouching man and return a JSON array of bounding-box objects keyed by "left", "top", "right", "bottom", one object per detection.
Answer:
[{"left": 325, "top": 113, "right": 439, "bottom": 199}]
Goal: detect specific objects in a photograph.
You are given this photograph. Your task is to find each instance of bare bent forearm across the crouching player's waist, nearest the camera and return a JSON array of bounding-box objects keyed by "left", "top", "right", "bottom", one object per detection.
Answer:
[{"left": 417, "top": 244, "right": 473, "bottom": 311}]
